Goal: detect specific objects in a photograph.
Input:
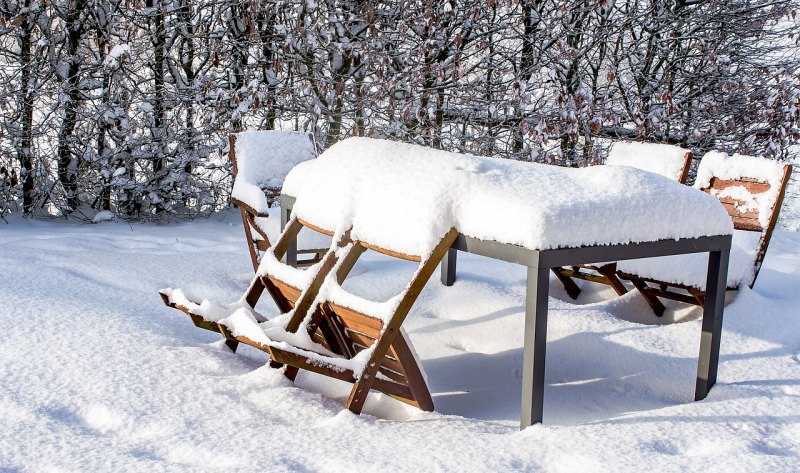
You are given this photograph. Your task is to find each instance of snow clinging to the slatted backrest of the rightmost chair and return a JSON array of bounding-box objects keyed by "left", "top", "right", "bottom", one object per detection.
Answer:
[{"left": 694, "top": 151, "right": 784, "bottom": 228}]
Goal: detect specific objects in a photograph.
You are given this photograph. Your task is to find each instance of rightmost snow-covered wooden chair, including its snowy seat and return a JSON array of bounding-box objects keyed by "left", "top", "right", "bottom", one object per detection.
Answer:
[{"left": 617, "top": 151, "right": 792, "bottom": 315}]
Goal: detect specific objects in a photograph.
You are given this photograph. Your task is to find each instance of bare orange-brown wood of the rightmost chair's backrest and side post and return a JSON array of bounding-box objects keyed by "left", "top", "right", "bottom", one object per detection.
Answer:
[{"left": 701, "top": 160, "right": 792, "bottom": 287}]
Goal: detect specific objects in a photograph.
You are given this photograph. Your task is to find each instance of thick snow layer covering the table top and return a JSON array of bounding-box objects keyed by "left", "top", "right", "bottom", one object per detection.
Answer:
[{"left": 284, "top": 138, "right": 733, "bottom": 256}]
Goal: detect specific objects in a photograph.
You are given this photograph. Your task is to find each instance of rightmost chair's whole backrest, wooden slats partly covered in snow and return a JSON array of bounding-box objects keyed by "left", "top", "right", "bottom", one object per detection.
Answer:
[{"left": 694, "top": 151, "right": 792, "bottom": 287}]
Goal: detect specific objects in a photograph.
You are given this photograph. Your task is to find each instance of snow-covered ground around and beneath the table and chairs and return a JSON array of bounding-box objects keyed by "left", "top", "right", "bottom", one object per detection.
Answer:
[{"left": 0, "top": 212, "right": 800, "bottom": 472}]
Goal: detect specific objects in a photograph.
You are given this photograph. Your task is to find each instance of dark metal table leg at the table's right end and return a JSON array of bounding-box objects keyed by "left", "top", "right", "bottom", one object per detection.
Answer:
[{"left": 694, "top": 249, "right": 730, "bottom": 401}]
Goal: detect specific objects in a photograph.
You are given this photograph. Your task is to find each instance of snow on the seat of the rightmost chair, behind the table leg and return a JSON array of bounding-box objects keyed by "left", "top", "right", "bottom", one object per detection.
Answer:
[{"left": 617, "top": 230, "right": 761, "bottom": 290}]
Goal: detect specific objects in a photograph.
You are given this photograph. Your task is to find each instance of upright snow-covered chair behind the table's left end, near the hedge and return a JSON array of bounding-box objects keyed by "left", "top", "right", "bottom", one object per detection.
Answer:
[{"left": 229, "top": 130, "right": 322, "bottom": 269}]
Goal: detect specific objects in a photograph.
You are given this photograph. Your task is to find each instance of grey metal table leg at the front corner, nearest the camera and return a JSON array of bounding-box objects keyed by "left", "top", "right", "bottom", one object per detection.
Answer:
[{"left": 520, "top": 267, "right": 550, "bottom": 429}]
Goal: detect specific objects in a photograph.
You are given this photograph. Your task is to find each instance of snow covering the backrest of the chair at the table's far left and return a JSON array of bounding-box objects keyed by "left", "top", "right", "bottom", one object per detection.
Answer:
[{"left": 231, "top": 130, "right": 316, "bottom": 213}]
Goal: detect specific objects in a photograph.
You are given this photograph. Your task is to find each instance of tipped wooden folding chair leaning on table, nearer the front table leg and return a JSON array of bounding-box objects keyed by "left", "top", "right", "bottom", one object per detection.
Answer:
[{"left": 236, "top": 229, "right": 458, "bottom": 413}]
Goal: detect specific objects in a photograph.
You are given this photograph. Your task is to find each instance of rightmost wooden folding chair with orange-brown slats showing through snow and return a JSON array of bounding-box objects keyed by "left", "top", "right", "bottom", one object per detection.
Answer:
[{"left": 617, "top": 152, "right": 792, "bottom": 316}]
